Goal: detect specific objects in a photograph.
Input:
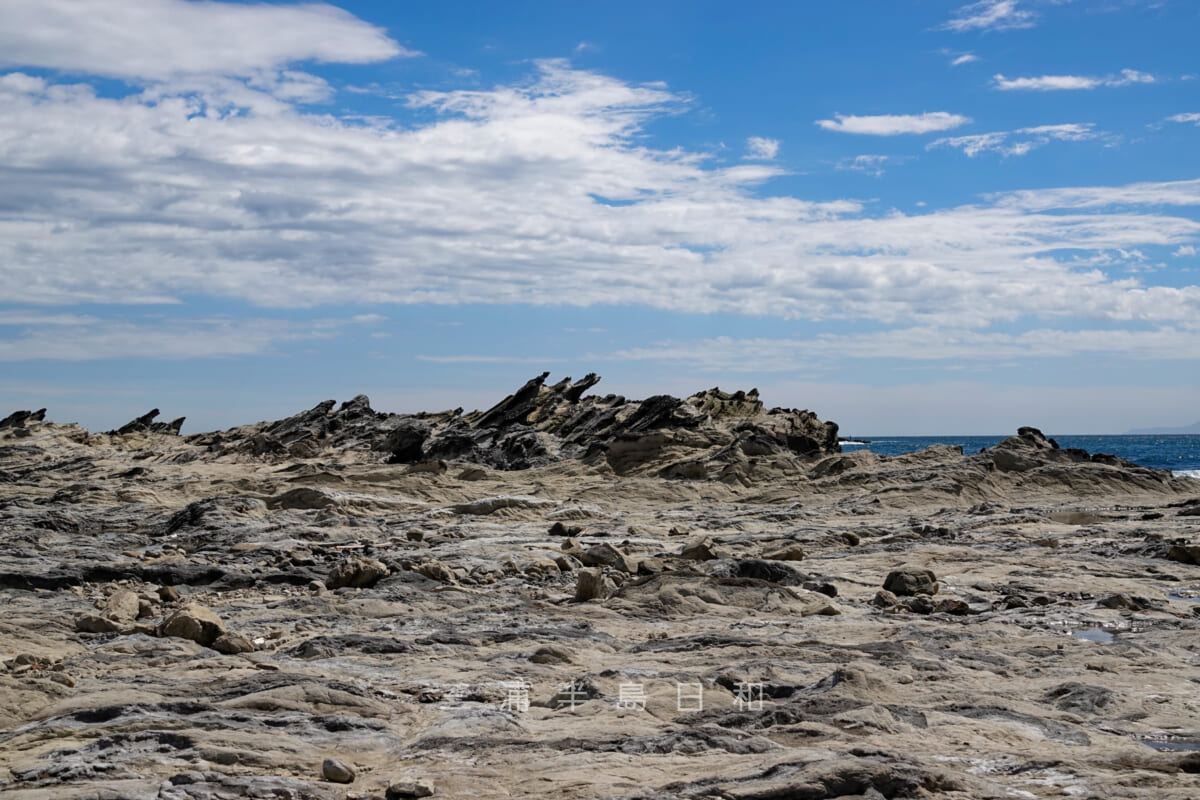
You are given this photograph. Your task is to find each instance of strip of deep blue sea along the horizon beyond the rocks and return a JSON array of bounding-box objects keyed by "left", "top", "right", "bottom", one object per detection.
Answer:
[{"left": 841, "top": 432, "right": 1200, "bottom": 477}]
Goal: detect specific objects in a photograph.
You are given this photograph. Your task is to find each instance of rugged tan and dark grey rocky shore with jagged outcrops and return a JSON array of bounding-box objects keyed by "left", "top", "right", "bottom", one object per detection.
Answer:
[{"left": 0, "top": 375, "right": 1200, "bottom": 800}]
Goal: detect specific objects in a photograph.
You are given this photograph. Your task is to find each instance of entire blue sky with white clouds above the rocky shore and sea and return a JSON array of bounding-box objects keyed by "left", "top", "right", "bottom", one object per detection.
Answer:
[{"left": 0, "top": 0, "right": 1200, "bottom": 435}]
